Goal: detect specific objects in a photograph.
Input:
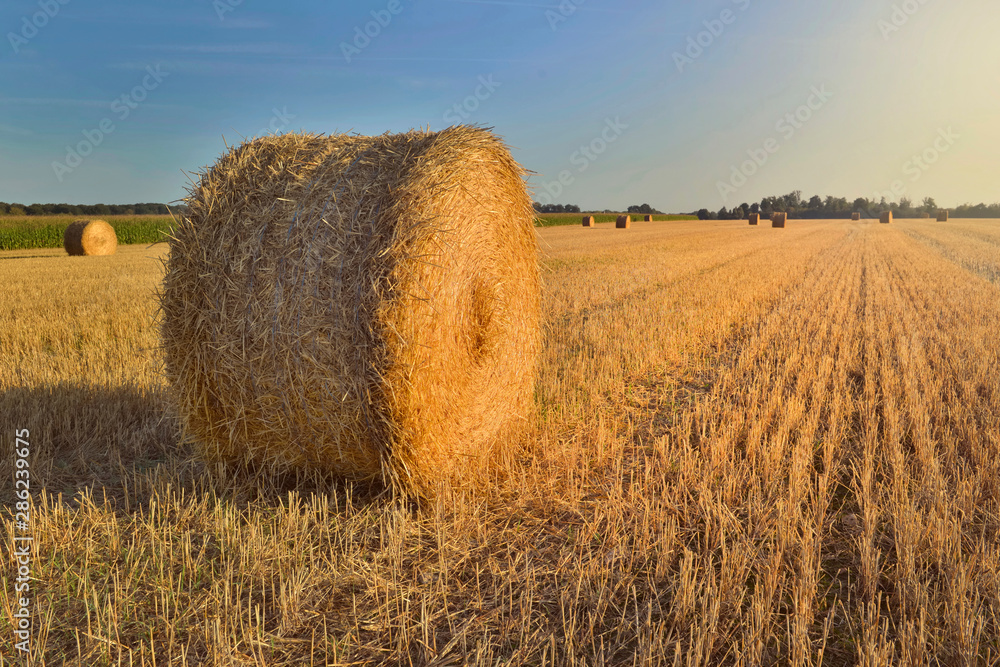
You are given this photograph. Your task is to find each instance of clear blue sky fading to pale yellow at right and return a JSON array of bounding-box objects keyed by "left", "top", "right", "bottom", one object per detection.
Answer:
[{"left": 0, "top": 0, "right": 1000, "bottom": 212}]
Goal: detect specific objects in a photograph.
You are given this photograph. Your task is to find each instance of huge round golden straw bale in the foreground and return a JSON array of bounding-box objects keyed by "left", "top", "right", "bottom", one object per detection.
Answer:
[{"left": 161, "top": 126, "right": 540, "bottom": 497}]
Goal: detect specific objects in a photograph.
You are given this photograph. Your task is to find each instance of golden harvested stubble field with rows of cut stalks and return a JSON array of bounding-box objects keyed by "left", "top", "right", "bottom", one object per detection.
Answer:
[{"left": 0, "top": 214, "right": 1000, "bottom": 665}]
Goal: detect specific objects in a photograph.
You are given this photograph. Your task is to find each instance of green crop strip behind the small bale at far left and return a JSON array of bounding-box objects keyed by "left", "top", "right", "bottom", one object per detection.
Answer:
[{"left": 0, "top": 215, "right": 172, "bottom": 250}]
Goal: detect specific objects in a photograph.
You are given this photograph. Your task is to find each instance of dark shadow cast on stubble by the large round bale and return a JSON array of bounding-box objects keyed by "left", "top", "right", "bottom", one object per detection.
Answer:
[{"left": 0, "top": 383, "right": 385, "bottom": 513}]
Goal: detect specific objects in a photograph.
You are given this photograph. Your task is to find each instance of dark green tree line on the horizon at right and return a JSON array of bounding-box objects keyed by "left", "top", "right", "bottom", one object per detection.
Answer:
[{"left": 691, "top": 190, "right": 1000, "bottom": 220}]
